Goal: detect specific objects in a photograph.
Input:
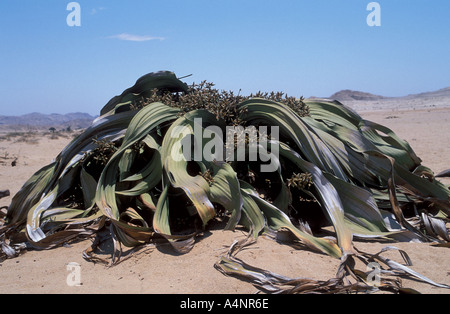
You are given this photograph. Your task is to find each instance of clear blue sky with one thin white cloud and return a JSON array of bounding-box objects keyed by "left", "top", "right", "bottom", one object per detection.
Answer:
[{"left": 0, "top": 0, "right": 450, "bottom": 115}]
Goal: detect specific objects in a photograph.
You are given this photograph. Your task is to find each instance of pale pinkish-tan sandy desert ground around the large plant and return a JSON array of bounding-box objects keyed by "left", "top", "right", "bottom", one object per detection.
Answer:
[{"left": 0, "top": 108, "right": 450, "bottom": 294}]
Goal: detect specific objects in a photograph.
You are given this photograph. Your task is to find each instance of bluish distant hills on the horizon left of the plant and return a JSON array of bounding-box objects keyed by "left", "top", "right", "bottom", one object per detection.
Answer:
[{"left": 0, "top": 112, "right": 95, "bottom": 129}]
